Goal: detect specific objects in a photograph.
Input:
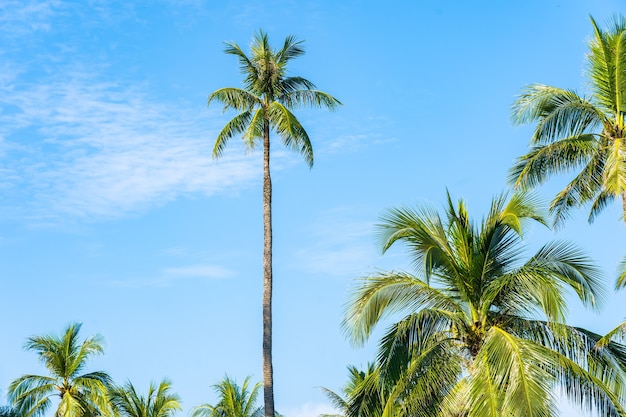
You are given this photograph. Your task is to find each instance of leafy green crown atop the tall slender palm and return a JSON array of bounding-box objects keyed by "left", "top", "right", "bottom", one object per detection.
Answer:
[{"left": 208, "top": 31, "right": 341, "bottom": 166}]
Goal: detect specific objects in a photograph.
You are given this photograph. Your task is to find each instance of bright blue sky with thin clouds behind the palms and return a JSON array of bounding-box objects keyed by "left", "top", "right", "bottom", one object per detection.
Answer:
[{"left": 0, "top": 0, "right": 626, "bottom": 417}]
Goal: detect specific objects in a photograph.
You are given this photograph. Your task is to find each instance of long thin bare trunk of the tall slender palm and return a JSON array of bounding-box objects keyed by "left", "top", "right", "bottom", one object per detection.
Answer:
[{"left": 263, "top": 121, "right": 274, "bottom": 417}]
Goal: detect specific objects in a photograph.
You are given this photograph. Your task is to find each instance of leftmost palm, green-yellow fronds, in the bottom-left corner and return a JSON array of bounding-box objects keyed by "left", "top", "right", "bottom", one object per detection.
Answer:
[{"left": 8, "top": 323, "right": 111, "bottom": 417}]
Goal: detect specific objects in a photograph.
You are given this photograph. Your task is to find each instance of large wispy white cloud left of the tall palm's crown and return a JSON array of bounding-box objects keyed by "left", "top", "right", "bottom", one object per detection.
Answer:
[{"left": 0, "top": 66, "right": 270, "bottom": 218}]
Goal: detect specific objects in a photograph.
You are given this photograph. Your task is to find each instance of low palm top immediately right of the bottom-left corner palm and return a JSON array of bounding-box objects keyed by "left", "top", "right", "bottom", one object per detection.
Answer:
[{"left": 109, "top": 380, "right": 182, "bottom": 417}]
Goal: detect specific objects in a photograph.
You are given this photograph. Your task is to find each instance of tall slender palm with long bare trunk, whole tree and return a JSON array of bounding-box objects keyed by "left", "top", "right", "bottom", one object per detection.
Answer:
[{"left": 208, "top": 31, "right": 341, "bottom": 417}]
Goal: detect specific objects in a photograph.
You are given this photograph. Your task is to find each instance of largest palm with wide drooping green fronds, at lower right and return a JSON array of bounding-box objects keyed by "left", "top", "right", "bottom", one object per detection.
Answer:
[{"left": 344, "top": 194, "right": 626, "bottom": 417}]
